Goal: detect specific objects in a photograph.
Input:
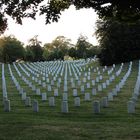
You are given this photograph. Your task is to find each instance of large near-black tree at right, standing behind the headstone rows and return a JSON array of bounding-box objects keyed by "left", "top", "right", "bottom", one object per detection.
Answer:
[{"left": 96, "top": 20, "right": 140, "bottom": 65}]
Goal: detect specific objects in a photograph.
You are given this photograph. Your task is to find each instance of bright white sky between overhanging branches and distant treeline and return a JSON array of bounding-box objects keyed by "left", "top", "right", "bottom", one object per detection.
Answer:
[{"left": 4, "top": 6, "right": 98, "bottom": 45}]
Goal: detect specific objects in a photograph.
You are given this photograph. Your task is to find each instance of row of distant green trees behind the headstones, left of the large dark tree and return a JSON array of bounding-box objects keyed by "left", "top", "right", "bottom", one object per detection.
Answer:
[{"left": 0, "top": 36, "right": 100, "bottom": 63}]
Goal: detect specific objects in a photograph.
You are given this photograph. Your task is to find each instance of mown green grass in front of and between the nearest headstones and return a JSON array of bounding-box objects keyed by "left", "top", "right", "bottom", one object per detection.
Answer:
[{"left": 0, "top": 61, "right": 140, "bottom": 140}]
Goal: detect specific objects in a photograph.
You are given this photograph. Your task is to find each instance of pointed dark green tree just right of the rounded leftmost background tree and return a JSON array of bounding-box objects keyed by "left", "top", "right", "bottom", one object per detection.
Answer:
[{"left": 26, "top": 36, "right": 43, "bottom": 61}]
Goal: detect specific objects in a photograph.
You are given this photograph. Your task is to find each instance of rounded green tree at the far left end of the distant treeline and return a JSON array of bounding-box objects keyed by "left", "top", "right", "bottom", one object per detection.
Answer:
[{"left": 0, "top": 36, "right": 25, "bottom": 63}]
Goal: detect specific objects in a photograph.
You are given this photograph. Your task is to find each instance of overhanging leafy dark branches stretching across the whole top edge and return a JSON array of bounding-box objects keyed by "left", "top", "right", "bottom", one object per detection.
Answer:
[{"left": 0, "top": 0, "right": 140, "bottom": 33}]
